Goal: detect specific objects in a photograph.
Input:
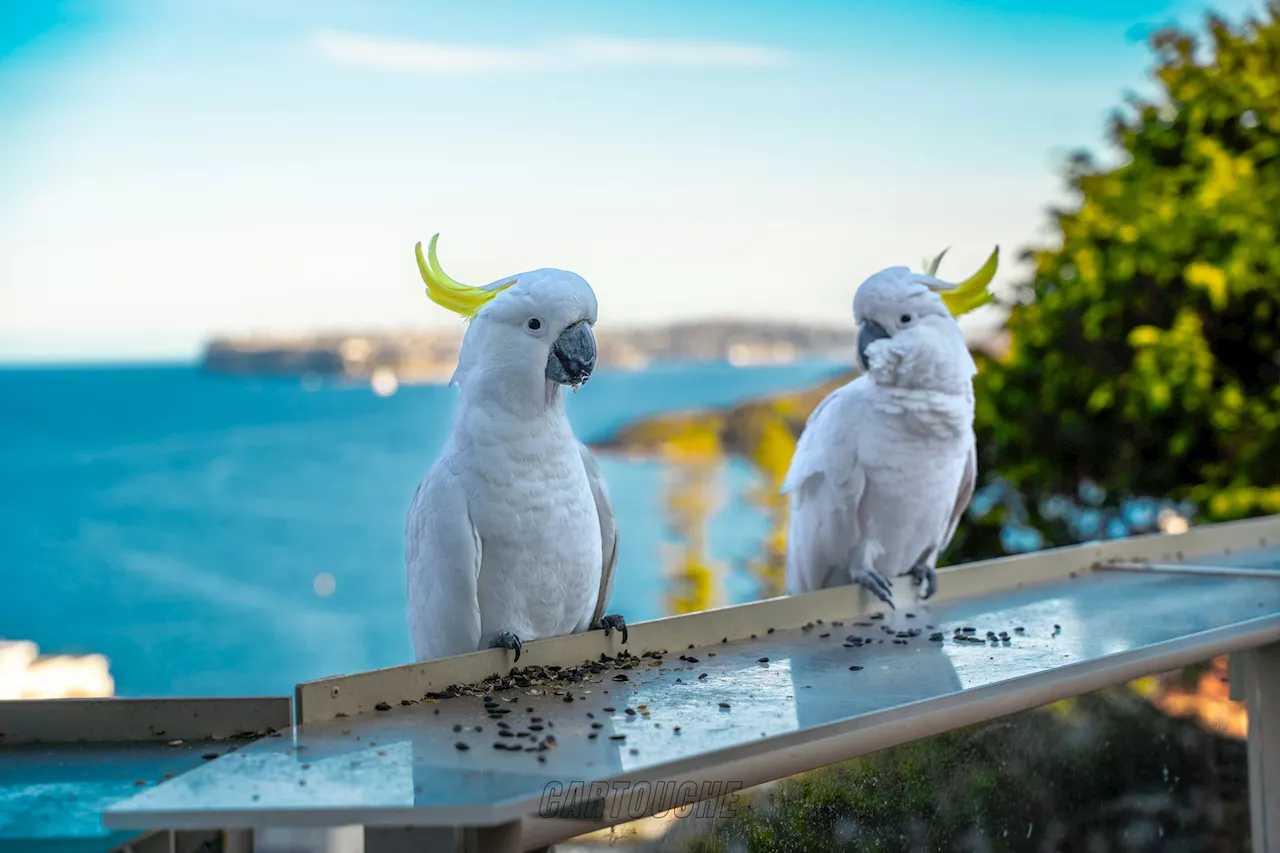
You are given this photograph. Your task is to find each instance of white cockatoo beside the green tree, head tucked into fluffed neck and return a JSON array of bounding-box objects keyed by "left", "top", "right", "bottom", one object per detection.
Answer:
[{"left": 782, "top": 247, "right": 1000, "bottom": 607}]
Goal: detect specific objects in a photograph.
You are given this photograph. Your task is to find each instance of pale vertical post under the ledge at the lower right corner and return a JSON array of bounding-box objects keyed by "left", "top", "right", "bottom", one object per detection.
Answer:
[{"left": 1231, "top": 643, "right": 1280, "bottom": 853}]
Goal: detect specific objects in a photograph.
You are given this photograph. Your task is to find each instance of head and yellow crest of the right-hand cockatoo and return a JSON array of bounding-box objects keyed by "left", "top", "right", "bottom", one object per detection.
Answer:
[{"left": 854, "top": 250, "right": 998, "bottom": 391}]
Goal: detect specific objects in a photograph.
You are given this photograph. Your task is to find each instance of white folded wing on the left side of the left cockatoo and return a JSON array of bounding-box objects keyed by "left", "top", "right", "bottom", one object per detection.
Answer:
[{"left": 404, "top": 462, "right": 481, "bottom": 661}]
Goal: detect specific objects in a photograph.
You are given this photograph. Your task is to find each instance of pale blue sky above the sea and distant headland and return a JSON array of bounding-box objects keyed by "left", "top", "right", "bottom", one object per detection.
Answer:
[{"left": 0, "top": 0, "right": 1257, "bottom": 360}]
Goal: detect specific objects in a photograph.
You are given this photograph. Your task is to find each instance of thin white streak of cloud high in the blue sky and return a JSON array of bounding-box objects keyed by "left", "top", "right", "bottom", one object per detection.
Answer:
[{"left": 311, "top": 29, "right": 788, "bottom": 74}]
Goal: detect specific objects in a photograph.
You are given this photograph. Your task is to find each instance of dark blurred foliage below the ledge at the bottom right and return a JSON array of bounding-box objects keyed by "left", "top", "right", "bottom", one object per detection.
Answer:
[{"left": 685, "top": 689, "right": 1249, "bottom": 853}]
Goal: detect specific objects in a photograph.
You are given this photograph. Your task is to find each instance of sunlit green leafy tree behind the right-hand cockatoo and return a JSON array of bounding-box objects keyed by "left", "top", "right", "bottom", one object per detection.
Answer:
[{"left": 952, "top": 0, "right": 1280, "bottom": 560}]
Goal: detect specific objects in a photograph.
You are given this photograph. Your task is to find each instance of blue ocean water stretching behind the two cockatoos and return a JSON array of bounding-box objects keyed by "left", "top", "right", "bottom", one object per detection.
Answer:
[{"left": 0, "top": 361, "right": 844, "bottom": 697}]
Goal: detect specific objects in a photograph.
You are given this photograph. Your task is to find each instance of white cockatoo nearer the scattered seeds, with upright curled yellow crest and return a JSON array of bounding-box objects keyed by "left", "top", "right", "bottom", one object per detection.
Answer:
[{"left": 404, "top": 234, "right": 627, "bottom": 661}]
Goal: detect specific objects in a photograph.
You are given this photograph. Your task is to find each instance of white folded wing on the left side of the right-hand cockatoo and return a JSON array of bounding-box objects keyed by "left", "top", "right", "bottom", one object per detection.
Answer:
[{"left": 782, "top": 378, "right": 872, "bottom": 594}]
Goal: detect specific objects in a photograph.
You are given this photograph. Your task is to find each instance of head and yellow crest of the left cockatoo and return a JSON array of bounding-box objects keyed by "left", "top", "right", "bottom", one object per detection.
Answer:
[{"left": 417, "top": 234, "right": 596, "bottom": 405}]
